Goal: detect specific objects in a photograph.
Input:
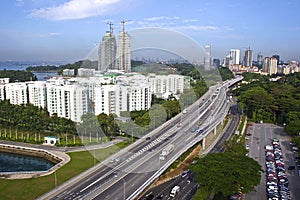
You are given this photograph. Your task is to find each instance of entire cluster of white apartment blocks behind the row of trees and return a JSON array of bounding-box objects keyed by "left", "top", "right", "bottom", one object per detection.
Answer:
[{"left": 0, "top": 73, "right": 190, "bottom": 122}]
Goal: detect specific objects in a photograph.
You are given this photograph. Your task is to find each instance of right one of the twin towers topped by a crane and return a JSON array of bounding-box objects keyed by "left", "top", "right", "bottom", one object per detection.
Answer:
[{"left": 117, "top": 21, "right": 131, "bottom": 72}]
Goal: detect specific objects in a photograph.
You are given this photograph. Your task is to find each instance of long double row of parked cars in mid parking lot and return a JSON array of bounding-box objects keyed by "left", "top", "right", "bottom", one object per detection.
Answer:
[{"left": 266, "top": 138, "right": 291, "bottom": 200}]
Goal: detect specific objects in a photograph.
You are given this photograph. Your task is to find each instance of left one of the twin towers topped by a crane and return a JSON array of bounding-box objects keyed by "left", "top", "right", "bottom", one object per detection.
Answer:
[{"left": 98, "top": 24, "right": 117, "bottom": 72}]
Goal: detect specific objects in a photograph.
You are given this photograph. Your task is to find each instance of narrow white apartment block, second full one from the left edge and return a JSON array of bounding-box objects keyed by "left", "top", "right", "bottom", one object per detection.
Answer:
[{"left": 26, "top": 81, "right": 47, "bottom": 108}]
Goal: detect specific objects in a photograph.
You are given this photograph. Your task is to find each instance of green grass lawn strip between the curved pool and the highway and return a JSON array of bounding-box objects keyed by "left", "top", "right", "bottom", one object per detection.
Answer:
[{"left": 0, "top": 141, "right": 129, "bottom": 200}]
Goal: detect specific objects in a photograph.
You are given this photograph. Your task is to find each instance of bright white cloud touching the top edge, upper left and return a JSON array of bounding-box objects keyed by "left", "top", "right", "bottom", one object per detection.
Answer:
[{"left": 29, "top": 0, "right": 121, "bottom": 20}]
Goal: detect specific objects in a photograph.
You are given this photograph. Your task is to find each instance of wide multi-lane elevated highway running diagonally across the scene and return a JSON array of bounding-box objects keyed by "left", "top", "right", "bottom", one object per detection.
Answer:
[{"left": 40, "top": 77, "right": 243, "bottom": 199}]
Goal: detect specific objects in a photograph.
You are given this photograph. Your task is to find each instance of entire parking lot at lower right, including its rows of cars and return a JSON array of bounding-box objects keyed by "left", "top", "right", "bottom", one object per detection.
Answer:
[{"left": 245, "top": 123, "right": 300, "bottom": 200}]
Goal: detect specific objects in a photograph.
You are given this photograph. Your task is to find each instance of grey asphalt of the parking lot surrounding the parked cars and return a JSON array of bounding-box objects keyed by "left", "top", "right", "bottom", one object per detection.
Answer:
[{"left": 245, "top": 123, "right": 300, "bottom": 200}]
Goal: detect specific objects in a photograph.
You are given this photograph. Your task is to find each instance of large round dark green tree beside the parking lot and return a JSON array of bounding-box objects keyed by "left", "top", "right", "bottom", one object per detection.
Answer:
[{"left": 190, "top": 152, "right": 262, "bottom": 196}]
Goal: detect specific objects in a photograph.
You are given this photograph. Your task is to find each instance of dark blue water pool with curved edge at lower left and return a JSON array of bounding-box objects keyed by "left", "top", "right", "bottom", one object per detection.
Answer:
[{"left": 0, "top": 152, "right": 55, "bottom": 172}]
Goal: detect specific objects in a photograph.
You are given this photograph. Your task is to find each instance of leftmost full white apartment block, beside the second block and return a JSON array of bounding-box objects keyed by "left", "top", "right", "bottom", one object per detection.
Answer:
[{"left": 5, "top": 82, "right": 28, "bottom": 105}]
